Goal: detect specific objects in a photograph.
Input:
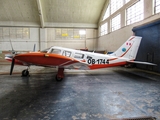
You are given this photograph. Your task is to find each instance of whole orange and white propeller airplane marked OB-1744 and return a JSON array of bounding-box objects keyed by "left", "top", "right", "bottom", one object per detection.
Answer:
[{"left": 5, "top": 36, "right": 155, "bottom": 81}]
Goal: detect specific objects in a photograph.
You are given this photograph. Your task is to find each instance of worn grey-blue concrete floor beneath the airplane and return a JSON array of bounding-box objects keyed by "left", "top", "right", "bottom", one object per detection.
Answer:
[{"left": 0, "top": 65, "right": 160, "bottom": 120}]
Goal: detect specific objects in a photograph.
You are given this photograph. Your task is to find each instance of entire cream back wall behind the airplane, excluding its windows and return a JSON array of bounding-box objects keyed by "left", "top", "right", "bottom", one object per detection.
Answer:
[{"left": 0, "top": 27, "right": 97, "bottom": 51}]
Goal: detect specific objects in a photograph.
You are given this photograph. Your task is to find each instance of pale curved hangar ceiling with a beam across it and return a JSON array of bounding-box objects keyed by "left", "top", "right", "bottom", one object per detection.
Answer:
[{"left": 0, "top": 0, "right": 108, "bottom": 28}]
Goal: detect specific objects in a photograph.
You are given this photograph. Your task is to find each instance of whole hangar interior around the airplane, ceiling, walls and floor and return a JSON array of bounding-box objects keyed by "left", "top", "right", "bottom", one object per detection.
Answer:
[{"left": 0, "top": 0, "right": 160, "bottom": 120}]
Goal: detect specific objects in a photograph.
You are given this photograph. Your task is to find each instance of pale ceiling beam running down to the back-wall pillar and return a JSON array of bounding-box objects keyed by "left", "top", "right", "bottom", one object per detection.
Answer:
[{"left": 37, "top": 0, "right": 44, "bottom": 28}]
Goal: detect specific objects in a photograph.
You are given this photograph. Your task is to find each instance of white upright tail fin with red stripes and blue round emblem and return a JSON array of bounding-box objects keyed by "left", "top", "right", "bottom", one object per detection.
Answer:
[{"left": 111, "top": 36, "right": 142, "bottom": 60}]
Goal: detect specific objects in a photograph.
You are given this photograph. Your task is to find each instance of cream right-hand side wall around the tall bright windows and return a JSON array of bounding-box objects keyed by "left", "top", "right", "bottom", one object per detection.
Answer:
[{"left": 97, "top": 0, "right": 160, "bottom": 52}]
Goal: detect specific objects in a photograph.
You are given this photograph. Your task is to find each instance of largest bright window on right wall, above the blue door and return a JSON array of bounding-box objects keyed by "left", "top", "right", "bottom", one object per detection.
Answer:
[{"left": 126, "top": 0, "right": 144, "bottom": 25}]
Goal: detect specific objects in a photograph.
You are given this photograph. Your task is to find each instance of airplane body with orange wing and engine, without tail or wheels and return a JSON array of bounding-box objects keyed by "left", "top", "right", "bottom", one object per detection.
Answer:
[{"left": 6, "top": 46, "right": 127, "bottom": 69}]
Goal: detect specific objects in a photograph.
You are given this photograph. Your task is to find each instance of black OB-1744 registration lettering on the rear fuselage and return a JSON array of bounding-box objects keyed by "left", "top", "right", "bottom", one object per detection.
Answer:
[{"left": 87, "top": 59, "right": 109, "bottom": 64}]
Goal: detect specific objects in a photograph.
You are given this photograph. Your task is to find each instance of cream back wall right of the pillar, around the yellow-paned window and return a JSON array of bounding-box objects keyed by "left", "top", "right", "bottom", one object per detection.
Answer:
[{"left": 46, "top": 28, "right": 97, "bottom": 50}]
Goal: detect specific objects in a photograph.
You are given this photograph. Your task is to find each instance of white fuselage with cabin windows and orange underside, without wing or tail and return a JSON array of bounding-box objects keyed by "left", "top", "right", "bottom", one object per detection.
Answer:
[{"left": 42, "top": 47, "right": 128, "bottom": 69}]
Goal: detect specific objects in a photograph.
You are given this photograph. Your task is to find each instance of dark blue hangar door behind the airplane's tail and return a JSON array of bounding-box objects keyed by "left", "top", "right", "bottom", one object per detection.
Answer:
[{"left": 132, "top": 19, "right": 160, "bottom": 72}]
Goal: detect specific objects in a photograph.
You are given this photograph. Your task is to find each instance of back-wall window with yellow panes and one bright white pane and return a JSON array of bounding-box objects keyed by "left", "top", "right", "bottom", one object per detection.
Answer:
[{"left": 55, "top": 28, "right": 86, "bottom": 40}]
